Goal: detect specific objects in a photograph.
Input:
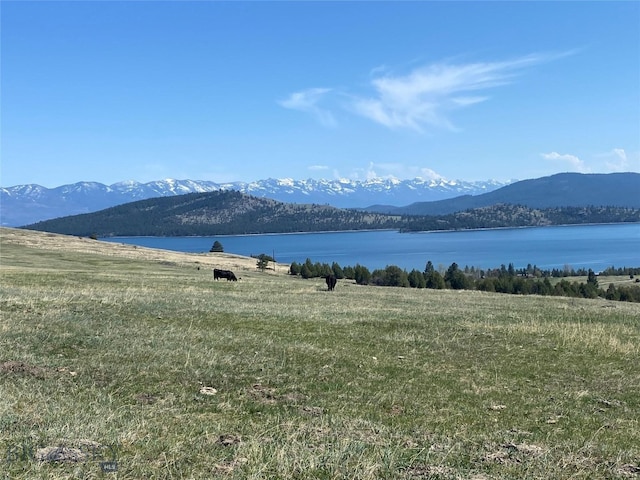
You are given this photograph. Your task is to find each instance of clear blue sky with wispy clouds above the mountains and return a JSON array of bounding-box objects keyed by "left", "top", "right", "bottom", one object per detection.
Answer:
[{"left": 0, "top": 1, "right": 640, "bottom": 187}]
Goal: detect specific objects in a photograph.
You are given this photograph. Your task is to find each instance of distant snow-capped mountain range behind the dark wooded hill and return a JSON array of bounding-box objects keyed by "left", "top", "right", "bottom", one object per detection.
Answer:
[{"left": 0, "top": 178, "right": 509, "bottom": 226}]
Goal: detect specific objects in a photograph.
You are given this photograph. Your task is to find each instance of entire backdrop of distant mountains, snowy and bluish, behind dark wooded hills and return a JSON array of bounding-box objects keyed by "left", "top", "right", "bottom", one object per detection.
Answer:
[{"left": 0, "top": 173, "right": 640, "bottom": 226}]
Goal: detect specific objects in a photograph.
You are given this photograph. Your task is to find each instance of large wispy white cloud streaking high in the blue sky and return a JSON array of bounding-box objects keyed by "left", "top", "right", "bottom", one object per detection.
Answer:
[{"left": 280, "top": 52, "right": 575, "bottom": 132}]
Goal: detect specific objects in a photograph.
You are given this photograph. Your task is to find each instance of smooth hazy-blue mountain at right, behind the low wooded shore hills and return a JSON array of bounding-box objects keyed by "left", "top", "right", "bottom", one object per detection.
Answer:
[{"left": 363, "top": 172, "right": 640, "bottom": 215}]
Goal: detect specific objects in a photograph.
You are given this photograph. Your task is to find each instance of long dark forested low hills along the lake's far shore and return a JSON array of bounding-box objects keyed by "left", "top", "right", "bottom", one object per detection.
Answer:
[{"left": 25, "top": 191, "right": 640, "bottom": 237}]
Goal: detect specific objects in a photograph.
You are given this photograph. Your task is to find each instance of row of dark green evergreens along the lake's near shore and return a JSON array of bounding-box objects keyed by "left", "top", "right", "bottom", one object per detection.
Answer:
[{"left": 289, "top": 258, "right": 640, "bottom": 303}]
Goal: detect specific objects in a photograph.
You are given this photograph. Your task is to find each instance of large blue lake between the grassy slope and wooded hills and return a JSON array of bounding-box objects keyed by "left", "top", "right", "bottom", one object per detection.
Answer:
[{"left": 104, "top": 223, "right": 640, "bottom": 272}]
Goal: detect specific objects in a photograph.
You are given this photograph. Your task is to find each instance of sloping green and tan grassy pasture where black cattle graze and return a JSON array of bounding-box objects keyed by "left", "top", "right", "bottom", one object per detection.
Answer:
[{"left": 0, "top": 229, "right": 640, "bottom": 480}]
